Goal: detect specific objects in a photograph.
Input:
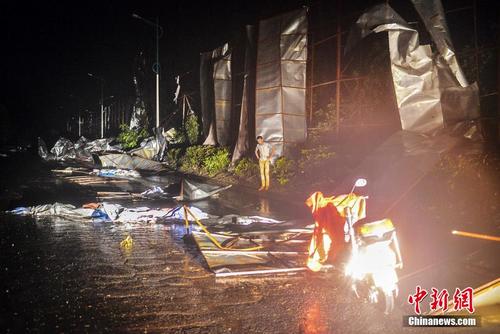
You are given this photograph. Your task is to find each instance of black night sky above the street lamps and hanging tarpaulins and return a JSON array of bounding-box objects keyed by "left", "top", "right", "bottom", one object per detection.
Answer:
[{"left": 0, "top": 1, "right": 305, "bottom": 142}]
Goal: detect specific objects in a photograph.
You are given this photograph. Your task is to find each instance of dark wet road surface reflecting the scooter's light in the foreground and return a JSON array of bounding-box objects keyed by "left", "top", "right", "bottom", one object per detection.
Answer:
[{"left": 0, "top": 153, "right": 498, "bottom": 333}]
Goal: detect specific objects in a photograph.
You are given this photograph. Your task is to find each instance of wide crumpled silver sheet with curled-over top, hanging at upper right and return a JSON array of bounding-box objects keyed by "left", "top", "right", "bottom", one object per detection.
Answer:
[{"left": 346, "top": 3, "right": 479, "bottom": 133}]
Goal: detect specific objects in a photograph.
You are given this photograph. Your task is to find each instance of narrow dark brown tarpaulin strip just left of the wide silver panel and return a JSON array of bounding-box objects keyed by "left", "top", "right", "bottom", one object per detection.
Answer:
[{"left": 232, "top": 25, "right": 257, "bottom": 163}]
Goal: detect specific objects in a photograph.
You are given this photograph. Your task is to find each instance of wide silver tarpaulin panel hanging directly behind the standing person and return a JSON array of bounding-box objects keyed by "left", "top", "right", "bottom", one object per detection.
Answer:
[{"left": 255, "top": 9, "right": 307, "bottom": 155}]
